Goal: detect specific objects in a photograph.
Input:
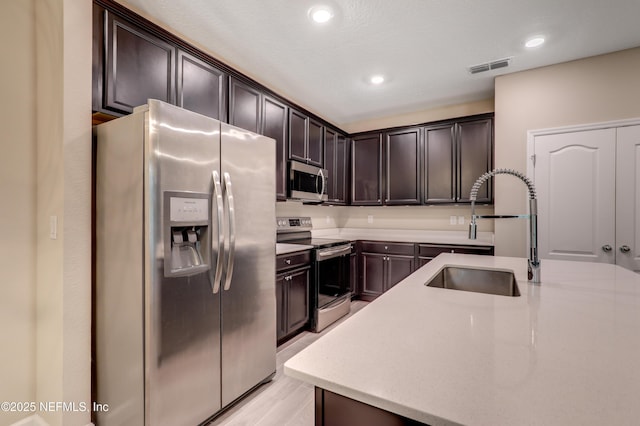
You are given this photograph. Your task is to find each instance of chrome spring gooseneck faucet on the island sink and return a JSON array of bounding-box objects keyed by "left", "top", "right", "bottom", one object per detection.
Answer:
[{"left": 469, "top": 169, "right": 540, "bottom": 283}]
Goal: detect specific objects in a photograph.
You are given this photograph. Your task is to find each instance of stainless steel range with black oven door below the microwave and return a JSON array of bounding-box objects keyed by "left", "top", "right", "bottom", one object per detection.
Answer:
[{"left": 276, "top": 217, "right": 351, "bottom": 332}]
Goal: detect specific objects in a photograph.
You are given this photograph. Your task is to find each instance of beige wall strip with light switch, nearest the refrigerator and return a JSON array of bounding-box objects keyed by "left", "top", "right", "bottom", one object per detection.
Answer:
[{"left": 35, "top": 0, "right": 92, "bottom": 425}]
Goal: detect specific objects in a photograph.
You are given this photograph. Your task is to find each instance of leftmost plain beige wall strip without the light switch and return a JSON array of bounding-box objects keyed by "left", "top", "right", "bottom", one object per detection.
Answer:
[{"left": 0, "top": 0, "right": 36, "bottom": 425}]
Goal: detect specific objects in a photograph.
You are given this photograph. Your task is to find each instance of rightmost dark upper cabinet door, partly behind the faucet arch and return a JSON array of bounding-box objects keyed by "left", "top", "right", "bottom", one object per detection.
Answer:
[{"left": 457, "top": 118, "right": 493, "bottom": 203}]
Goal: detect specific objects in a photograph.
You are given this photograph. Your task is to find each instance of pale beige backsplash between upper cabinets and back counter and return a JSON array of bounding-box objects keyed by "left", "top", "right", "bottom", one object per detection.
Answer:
[{"left": 276, "top": 201, "right": 494, "bottom": 232}]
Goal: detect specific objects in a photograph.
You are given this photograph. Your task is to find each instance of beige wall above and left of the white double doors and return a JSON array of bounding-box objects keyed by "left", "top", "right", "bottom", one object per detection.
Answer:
[{"left": 495, "top": 48, "right": 640, "bottom": 256}]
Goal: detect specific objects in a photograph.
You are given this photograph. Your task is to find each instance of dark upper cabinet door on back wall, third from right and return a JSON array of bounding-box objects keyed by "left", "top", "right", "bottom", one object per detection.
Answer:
[{"left": 384, "top": 127, "right": 420, "bottom": 204}]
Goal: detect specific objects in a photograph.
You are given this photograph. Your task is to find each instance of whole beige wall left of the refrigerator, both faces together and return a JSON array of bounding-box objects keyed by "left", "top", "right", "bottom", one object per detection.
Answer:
[{"left": 0, "top": 0, "right": 92, "bottom": 425}]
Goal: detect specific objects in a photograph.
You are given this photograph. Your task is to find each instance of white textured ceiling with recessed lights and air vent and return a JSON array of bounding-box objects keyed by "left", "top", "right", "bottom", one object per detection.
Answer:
[{"left": 118, "top": 0, "right": 640, "bottom": 126}]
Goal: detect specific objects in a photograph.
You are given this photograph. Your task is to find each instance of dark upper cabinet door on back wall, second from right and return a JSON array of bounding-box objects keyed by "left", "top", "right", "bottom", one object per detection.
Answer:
[{"left": 423, "top": 124, "right": 456, "bottom": 203}]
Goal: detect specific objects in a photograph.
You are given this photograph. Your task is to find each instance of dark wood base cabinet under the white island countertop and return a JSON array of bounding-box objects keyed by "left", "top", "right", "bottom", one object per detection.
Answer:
[{"left": 315, "top": 387, "right": 425, "bottom": 426}]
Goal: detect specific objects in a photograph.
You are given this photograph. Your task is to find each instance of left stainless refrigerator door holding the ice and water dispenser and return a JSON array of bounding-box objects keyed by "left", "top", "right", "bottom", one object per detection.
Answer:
[{"left": 145, "top": 100, "right": 221, "bottom": 426}]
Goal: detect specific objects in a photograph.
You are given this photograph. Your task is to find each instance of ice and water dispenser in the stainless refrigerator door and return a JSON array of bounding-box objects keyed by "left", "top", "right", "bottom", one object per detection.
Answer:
[{"left": 164, "top": 192, "right": 211, "bottom": 277}]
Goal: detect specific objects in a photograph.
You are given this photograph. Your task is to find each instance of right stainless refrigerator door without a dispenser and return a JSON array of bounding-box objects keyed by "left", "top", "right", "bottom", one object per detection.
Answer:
[{"left": 221, "top": 123, "right": 276, "bottom": 406}]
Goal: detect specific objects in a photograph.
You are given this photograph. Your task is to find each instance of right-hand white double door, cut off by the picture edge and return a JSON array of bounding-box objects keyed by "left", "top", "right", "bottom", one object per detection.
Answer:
[{"left": 615, "top": 126, "right": 640, "bottom": 272}]
